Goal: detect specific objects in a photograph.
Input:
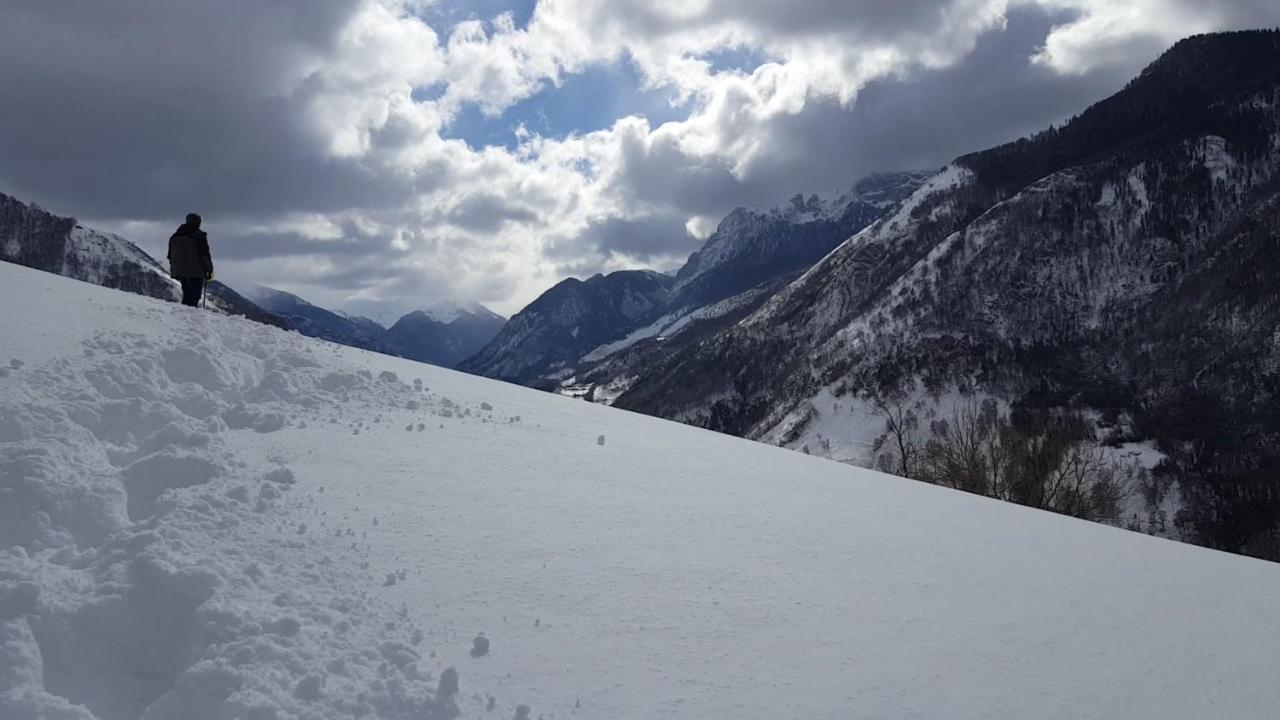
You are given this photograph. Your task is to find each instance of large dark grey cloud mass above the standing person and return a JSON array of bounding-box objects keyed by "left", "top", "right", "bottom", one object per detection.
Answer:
[{"left": 0, "top": 0, "right": 404, "bottom": 219}]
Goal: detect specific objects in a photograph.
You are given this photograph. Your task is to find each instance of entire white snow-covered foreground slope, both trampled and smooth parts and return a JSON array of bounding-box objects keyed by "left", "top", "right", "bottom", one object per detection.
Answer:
[{"left": 0, "top": 258, "right": 1280, "bottom": 720}]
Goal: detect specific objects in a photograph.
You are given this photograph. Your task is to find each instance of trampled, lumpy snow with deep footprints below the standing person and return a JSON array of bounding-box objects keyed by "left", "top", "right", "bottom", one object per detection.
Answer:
[{"left": 0, "top": 268, "right": 471, "bottom": 720}]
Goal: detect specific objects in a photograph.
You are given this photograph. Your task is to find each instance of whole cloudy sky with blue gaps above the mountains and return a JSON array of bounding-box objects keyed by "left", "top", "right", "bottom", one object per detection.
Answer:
[{"left": 0, "top": 0, "right": 1280, "bottom": 316}]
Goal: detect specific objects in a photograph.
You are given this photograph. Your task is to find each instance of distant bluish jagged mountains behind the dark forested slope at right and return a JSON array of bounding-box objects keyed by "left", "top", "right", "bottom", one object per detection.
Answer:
[{"left": 458, "top": 173, "right": 927, "bottom": 398}]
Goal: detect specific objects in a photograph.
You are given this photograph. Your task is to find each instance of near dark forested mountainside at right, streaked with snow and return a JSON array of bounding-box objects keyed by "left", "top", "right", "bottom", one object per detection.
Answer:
[{"left": 616, "top": 31, "right": 1280, "bottom": 559}]
